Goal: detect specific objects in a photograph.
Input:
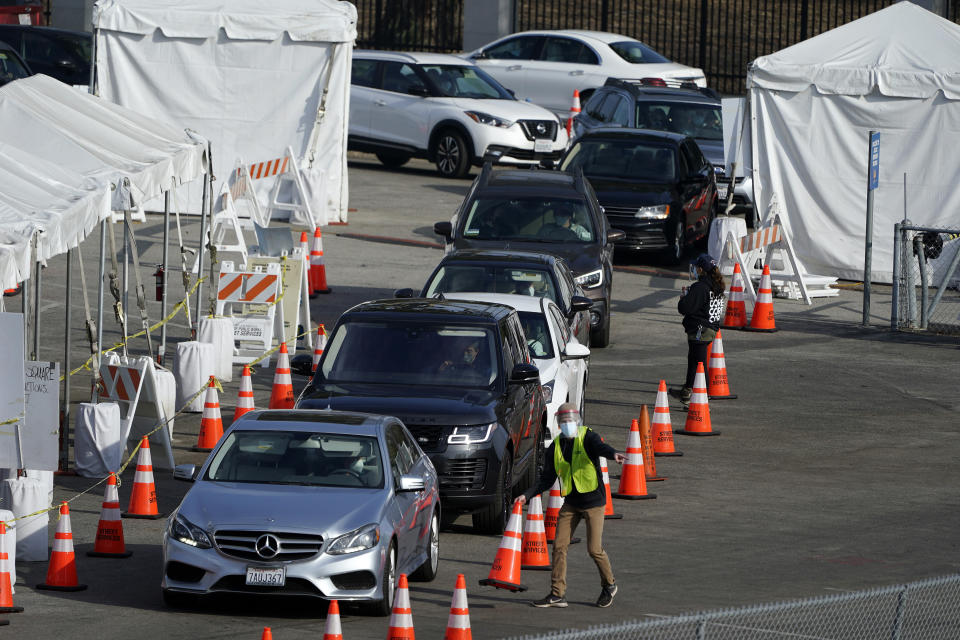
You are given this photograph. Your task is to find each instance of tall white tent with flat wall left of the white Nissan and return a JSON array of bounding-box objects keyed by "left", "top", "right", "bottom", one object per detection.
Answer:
[{"left": 93, "top": 0, "right": 357, "bottom": 223}]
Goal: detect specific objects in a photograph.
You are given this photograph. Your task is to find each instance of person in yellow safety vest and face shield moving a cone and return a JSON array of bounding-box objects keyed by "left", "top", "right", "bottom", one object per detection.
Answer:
[{"left": 517, "top": 402, "right": 627, "bottom": 607}]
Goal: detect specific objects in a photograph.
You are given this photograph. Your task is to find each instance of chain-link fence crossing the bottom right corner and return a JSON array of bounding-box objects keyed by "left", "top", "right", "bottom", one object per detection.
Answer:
[{"left": 498, "top": 575, "right": 960, "bottom": 640}]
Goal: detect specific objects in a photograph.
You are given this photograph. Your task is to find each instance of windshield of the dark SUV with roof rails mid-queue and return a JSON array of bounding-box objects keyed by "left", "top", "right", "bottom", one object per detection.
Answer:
[{"left": 463, "top": 196, "right": 596, "bottom": 244}]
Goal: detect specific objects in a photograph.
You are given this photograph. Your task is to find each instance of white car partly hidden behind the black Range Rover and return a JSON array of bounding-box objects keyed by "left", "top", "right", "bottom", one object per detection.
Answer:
[{"left": 443, "top": 293, "right": 590, "bottom": 446}]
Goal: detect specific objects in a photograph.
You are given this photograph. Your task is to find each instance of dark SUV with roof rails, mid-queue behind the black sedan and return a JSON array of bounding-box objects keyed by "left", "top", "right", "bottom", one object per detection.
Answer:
[{"left": 433, "top": 164, "right": 623, "bottom": 347}]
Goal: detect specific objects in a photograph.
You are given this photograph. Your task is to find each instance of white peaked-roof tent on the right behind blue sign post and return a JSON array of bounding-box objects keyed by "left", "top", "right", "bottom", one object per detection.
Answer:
[{"left": 747, "top": 2, "right": 960, "bottom": 282}]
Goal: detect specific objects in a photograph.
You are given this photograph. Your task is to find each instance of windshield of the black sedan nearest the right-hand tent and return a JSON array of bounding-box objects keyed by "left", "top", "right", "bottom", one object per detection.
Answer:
[{"left": 560, "top": 139, "right": 676, "bottom": 182}]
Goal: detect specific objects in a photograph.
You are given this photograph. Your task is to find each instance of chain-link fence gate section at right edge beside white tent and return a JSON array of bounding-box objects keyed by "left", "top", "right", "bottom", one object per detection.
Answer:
[{"left": 890, "top": 220, "right": 960, "bottom": 335}]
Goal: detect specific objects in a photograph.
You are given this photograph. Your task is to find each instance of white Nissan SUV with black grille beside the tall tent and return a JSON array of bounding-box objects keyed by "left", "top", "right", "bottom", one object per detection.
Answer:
[{"left": 348, "top": 51, "right": 567, "bottom": 178}]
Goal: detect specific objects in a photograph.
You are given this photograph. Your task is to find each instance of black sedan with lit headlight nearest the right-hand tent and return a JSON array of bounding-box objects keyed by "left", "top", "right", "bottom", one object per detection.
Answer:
[{"left": 560, "top": 128, "right": 717, "bottom": 263}]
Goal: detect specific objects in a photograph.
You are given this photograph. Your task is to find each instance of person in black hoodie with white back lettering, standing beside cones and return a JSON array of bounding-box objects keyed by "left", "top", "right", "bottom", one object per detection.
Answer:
[{"left": 670, "top": 253, "right": 726, "bottom": 402}]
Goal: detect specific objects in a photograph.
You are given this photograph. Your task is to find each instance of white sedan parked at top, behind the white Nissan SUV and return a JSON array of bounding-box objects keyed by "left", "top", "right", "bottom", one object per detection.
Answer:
[{"left": 464, "top": 30, "right": 707, "bottom": 119}]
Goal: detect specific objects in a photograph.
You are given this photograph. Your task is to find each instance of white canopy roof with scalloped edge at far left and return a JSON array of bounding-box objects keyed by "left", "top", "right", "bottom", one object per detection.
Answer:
[{"left": 0, "top": 75, "right": 206, "bottom": 288}]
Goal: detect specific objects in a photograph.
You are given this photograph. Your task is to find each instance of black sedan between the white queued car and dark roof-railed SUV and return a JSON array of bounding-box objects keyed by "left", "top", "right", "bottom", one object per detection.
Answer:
[{"left": 394, "top": 249, "right": 592, "bottom": 347}]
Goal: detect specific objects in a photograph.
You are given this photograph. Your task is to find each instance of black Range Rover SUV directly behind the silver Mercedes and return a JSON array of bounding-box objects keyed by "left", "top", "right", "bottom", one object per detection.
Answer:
[{"left": 294, "top": 298, "right": 547, "bottom": 533}]
